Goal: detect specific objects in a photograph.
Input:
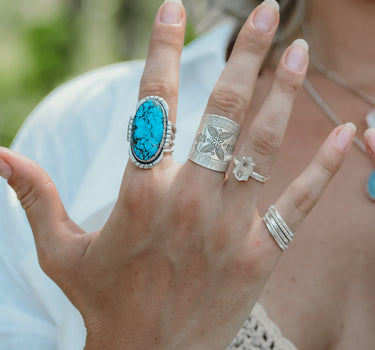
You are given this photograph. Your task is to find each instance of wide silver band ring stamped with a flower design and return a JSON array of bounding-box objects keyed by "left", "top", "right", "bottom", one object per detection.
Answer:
[{"left": 189, "top": 114, "right": 241, "bottom": 173}]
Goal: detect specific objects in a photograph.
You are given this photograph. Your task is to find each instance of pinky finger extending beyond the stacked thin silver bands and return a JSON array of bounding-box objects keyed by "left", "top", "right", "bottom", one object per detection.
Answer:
[{"left": 263, "top": 123, "right": 356, "bottom": 249}]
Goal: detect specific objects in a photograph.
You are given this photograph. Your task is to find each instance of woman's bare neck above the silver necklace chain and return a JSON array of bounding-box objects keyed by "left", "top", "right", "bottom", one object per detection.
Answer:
[{"left": 308, "top": 0, "right": 375, "bottom": 90}]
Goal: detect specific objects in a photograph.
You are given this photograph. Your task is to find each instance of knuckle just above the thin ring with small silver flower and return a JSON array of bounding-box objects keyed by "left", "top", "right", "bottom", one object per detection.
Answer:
[{"left": 252, "top": 123, "right": 281, "bottom": 157}]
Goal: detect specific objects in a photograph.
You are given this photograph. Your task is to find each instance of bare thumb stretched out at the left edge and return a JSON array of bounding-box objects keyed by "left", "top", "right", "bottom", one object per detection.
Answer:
[{"left": 0, "top": 147, "right": 84, "bottom": 254}]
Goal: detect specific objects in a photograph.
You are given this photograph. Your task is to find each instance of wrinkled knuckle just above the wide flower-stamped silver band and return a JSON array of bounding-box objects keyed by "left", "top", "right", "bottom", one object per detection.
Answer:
[{"left": 207, "top": 87, "right": 248, "bottom": 121}]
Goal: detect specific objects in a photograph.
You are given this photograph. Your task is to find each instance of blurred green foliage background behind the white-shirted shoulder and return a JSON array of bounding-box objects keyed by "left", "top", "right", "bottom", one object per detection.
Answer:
[{"left": 0, "top": 0, "right": 198, "bottom": 146}]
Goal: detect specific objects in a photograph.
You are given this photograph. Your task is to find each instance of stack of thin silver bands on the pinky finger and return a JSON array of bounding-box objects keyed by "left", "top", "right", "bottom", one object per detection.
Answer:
[{"left": 263, "top": 205, "right": 295, "bottom": 250}]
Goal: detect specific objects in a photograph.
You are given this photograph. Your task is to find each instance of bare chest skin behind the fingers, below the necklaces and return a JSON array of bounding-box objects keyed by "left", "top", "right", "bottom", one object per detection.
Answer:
[{"left": 250, "top": 69, "right": 375, "bottom": 350}]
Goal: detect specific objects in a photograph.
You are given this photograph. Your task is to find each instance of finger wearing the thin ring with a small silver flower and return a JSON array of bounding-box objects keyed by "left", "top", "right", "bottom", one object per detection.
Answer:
[{"left": 226, "top": 40, "right": 308, "bottom": 213}]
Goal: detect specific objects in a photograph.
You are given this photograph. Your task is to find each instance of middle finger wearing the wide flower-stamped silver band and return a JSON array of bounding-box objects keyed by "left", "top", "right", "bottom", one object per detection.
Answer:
[{"left": 186, "top": 0, "right": 279, "bottom": 188}]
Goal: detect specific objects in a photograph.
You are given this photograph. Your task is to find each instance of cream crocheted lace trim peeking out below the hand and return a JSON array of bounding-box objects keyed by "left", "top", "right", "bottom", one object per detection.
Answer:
[{"left": 226, "top": 303, "right": 297, "bottom": 350}]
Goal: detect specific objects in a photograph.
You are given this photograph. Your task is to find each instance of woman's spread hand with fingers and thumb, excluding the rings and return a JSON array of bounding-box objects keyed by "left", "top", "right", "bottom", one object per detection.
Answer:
[{"left": 0, "top": 1, "right": 354, "bottom": 350}]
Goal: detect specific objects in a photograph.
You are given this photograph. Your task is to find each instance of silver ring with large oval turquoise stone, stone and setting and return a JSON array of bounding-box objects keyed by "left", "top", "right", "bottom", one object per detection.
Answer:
[{"left": 127, "top": 96, "right": 177, "bottom": 169}]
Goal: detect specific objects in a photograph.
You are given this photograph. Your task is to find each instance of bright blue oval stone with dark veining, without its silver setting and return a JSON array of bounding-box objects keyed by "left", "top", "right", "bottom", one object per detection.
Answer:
[{"left": 131, "top": 101, "right": 167, "bottom": 163}]
